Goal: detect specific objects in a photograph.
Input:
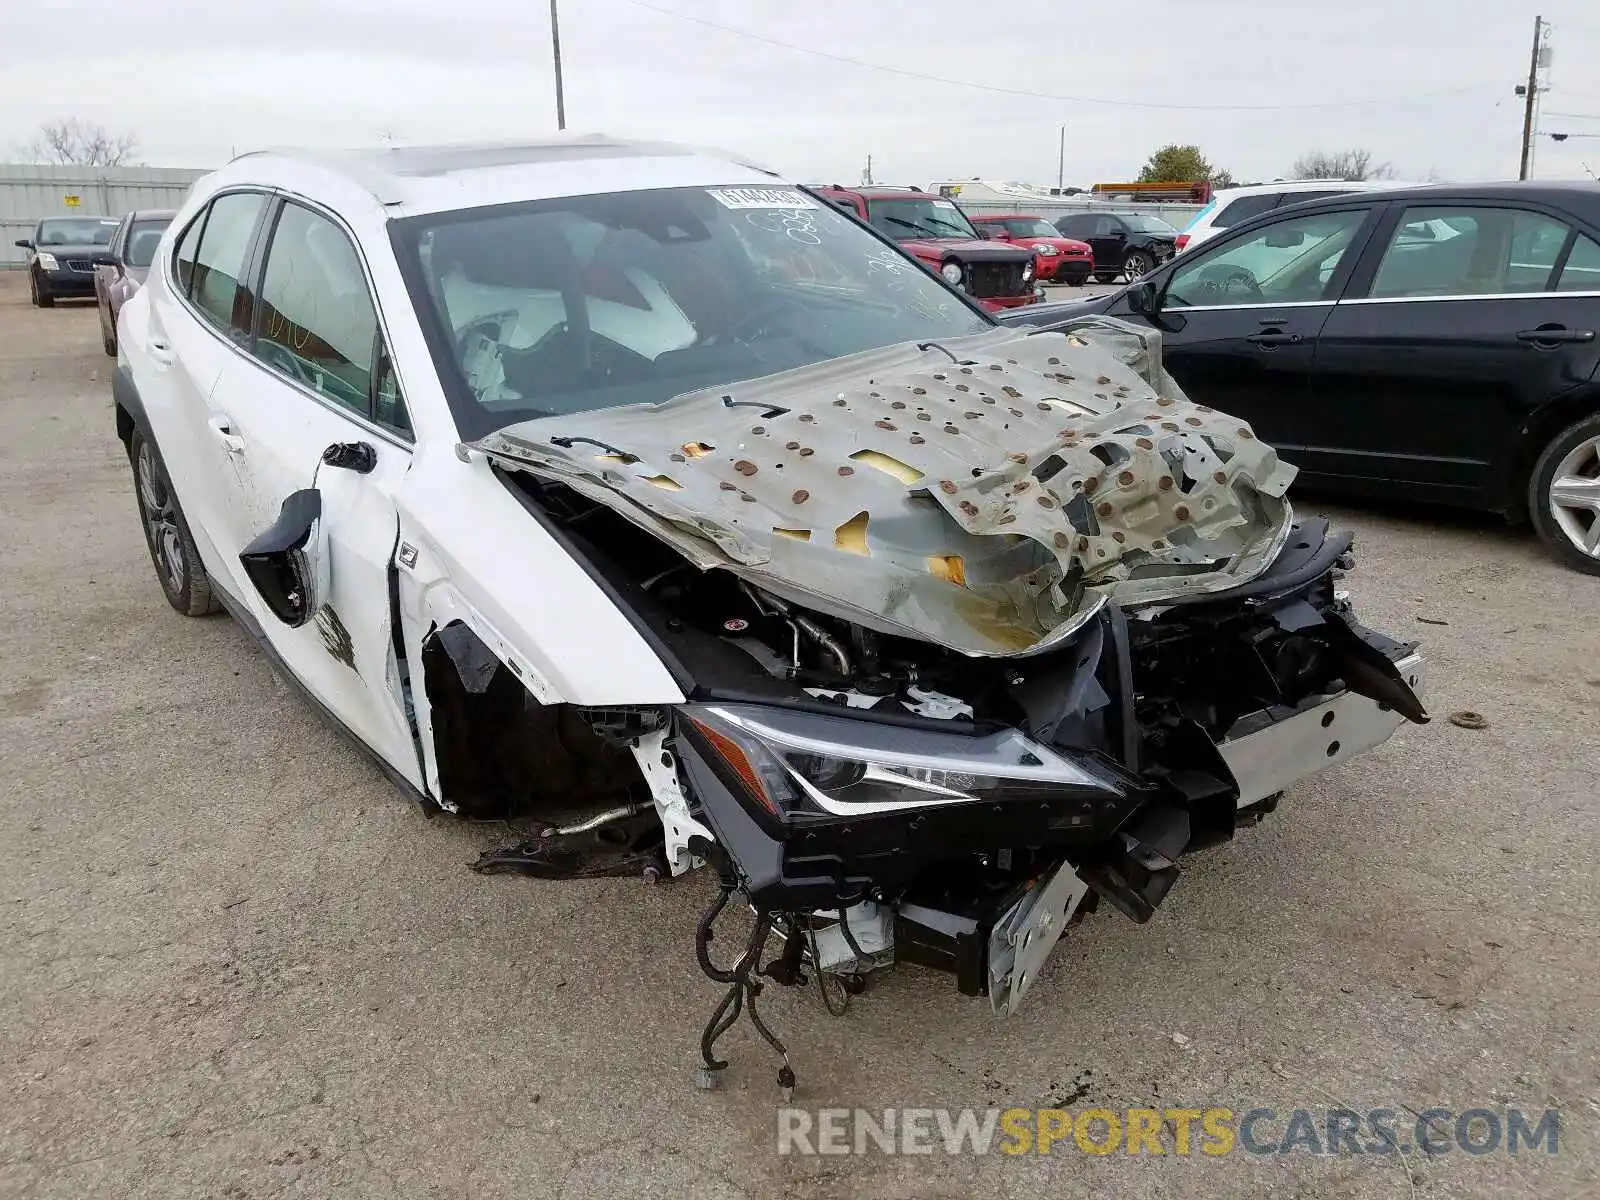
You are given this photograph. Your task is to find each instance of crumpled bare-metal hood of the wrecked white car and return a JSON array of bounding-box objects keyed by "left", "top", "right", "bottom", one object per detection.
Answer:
[{"left": 474, "top": 317, "right": 1294, "bottom": 656}]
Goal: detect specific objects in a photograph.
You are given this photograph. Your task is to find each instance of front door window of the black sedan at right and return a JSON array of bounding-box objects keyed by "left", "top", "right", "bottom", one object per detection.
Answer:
[{"left": 1163, "top": 208, "right": 1368, "bottom": 309}]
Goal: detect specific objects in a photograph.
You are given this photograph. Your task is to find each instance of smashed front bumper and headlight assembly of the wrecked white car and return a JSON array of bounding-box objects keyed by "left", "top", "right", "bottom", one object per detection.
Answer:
[{"left": 656, "top": 522, "right": 1427, "bottom": 1088}]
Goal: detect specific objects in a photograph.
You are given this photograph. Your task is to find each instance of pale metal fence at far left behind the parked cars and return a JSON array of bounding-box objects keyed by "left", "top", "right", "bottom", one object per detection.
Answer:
[{"left": 0, "top": 163, "right": 205, "bottom": 267}]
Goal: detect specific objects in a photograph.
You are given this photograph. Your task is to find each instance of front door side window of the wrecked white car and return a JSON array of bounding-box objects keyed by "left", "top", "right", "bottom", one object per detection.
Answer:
[{"left": 256, "top": 203, "right": 378, "bottom": 416}]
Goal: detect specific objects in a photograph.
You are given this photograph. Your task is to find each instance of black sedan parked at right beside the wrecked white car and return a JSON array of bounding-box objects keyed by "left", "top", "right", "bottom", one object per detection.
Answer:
[{"left": 1003, "top": 184, "right": 1600, "bottom": 574}]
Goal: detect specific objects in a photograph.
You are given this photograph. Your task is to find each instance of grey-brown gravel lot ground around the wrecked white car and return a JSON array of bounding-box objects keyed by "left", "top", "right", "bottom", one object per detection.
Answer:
[{"left": 0, "top": 275, "right": 1600, "bottom": 1200}]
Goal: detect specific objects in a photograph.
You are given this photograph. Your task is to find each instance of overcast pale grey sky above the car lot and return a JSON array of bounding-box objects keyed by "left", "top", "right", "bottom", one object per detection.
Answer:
[{"left": 0, "top": 0, "right": 1600, "bottom": 186}]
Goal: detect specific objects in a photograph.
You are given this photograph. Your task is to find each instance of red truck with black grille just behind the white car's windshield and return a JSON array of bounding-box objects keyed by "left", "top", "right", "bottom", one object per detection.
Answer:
[{"left": 813, "top": 186, "right": 1043, "bottom": 310}]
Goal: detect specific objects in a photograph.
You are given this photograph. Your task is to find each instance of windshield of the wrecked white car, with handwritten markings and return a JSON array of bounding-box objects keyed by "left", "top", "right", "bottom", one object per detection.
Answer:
[{"left": 392, "top": 187, "right": 990, "bottom": 438}]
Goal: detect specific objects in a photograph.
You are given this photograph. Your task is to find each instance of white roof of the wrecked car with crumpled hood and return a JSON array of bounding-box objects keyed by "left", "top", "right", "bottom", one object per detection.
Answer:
[{"left": 213, "top": 134, "right": 781, "bottom": 216}]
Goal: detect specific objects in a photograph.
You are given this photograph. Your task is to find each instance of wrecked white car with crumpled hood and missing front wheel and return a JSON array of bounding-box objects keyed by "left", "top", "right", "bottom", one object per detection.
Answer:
[{"left": 114, "top": 139, "right": 1426, "bottom": 1086}]
